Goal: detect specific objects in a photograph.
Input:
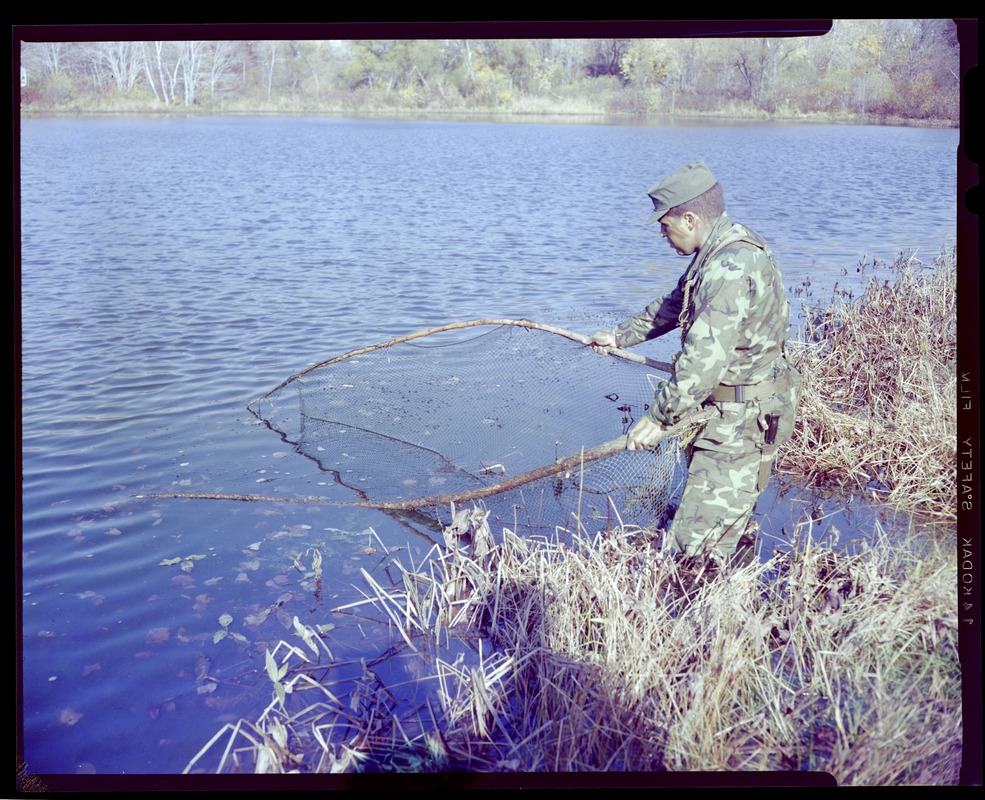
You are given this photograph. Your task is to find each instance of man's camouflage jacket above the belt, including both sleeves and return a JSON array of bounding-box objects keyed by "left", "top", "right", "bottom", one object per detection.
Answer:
[{"left": 615, "top": 209, "right": 790, "bottom": 425}]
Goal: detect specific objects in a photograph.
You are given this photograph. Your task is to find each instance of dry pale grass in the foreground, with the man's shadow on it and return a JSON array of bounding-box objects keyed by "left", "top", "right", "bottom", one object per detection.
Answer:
[{"left": 186, "top": 521, "right": 961, "bottom": 785}]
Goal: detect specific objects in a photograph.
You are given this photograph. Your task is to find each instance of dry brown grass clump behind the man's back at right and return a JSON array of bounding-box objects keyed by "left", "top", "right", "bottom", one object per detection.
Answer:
[{"left": 777, "top": 251, "right": 957, "bottom": 523}]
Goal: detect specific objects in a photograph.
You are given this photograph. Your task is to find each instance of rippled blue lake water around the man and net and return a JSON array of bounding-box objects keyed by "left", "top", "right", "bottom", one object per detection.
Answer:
[{"left": 20, "top": 118, "right": 958, "bottom": 774}]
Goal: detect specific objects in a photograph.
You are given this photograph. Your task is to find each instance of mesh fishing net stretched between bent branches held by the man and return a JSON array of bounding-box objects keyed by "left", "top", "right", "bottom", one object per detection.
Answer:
[{"left": 249, "top": 320, "right": 686, "bottom": 530}]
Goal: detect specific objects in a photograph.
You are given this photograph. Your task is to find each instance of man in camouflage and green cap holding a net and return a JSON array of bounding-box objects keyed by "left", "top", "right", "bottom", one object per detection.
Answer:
[{"left": 590, "top": 162, "right": 801, "bottom": 557}]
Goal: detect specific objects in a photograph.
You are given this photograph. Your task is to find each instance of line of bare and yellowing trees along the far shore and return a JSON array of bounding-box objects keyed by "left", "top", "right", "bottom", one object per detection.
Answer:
[{"left": 20, "top": 19, "right": 960, "bottom": 124}]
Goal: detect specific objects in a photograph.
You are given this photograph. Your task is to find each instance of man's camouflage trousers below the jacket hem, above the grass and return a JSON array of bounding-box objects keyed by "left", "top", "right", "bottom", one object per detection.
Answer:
[{"left": 667, "top": 448, "right": 762, "bottom": 556}]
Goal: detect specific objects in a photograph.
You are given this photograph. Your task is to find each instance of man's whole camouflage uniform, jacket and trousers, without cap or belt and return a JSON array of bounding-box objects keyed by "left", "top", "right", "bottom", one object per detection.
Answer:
[{"left": 615, "top": 214, "right": 800, "bottom": 555}]
